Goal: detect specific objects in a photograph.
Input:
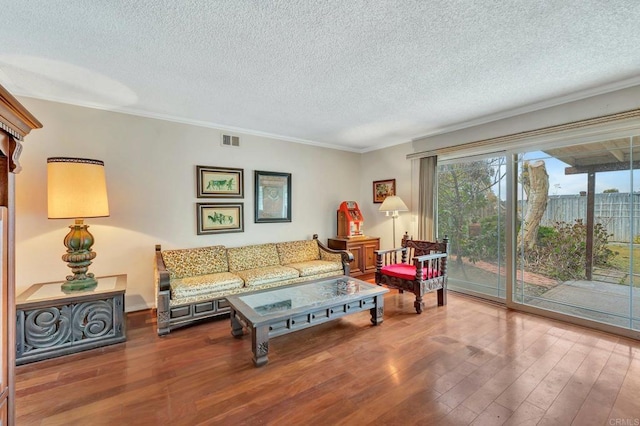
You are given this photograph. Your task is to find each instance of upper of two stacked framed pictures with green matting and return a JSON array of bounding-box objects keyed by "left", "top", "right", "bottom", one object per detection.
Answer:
[{"left": 196, "top": 166, "right": 244, "bottom": 198}]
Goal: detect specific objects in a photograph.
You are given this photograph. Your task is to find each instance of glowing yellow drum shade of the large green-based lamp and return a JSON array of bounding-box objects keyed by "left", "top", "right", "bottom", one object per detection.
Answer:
[{"left": 47, "top": 157, "right": 109, "bottom": 219}]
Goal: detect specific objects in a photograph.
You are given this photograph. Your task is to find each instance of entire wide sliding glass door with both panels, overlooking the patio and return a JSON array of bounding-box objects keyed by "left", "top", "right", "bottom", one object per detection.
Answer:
[{"left": 424, "top": 110, "right": 640, "bottom": 338}]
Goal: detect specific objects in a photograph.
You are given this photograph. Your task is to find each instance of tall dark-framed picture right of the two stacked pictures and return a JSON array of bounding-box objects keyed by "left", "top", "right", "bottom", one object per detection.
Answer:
[{"left": 254, "top": 170, "right": 291, "bottom": 223}]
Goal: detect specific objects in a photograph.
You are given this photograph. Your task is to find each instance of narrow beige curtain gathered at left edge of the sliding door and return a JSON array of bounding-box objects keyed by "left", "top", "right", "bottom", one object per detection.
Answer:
[{"left": 418, "top": 155, "right": 438, "bottom": 241}]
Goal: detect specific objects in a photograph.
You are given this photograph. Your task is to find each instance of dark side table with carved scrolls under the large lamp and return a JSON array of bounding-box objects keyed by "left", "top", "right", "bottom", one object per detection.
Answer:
[{"left": 16, "top": 275, "right": 127, "bottom": 365}]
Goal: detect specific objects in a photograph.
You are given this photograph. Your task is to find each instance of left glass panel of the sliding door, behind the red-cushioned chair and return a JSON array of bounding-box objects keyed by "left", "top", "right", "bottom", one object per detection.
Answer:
[{"left": 438, "top": 155, "right": 506, "bottom": 300}]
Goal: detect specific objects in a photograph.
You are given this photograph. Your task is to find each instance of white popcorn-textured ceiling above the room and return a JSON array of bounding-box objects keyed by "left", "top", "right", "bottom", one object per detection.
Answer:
[{"left": 0, "top": 0, "right": 640, "bottom": 152}]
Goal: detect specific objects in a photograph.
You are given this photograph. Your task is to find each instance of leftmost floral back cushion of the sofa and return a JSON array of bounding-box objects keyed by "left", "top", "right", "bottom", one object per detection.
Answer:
[{"left": 162, "top": 246, "right": 229, "bottom": 279}]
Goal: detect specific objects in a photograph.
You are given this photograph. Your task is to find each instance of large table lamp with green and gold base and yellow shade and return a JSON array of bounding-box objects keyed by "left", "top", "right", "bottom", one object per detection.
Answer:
[{"left": 47, "top": 157, "right": 109, "bottom": 292}]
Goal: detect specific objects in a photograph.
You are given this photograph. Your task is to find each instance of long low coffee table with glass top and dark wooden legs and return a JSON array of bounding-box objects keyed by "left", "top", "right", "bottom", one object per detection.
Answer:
[{"left": 227, "top": 276, "right": 389, "bottom": 367}]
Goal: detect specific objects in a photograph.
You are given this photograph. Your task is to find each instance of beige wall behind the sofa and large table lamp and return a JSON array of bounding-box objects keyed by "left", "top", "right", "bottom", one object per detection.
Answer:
[{"left": 16, "top": 98, "right": 362, "bottom": 311}]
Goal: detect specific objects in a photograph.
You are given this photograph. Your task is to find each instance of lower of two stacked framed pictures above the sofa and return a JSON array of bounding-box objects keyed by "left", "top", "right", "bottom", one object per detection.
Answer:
[{"left": 196, "top": 203, "right": 244, "bottom": 235}]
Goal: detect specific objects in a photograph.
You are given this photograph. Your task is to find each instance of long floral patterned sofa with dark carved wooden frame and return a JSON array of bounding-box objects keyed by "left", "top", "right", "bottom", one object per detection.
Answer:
[{"left": 155, "top": 235, "right": 353, "bottom": 336}]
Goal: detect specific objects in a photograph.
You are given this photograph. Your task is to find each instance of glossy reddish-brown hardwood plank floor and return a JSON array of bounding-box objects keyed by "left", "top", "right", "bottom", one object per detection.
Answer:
[{"left": 16, "top": 291, "right": 640, "bottom": 425}]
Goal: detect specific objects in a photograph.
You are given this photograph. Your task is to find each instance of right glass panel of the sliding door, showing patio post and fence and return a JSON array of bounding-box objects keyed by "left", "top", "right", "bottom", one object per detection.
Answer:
[{"left": 512, "top": 137, "right": 640, "bottom": 330}]
